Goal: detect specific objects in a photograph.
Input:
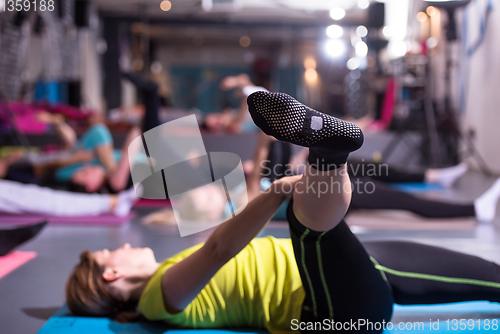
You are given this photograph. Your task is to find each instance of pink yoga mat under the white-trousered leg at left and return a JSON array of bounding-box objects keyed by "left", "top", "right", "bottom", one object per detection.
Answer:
[{"left": 0, "top": 212, "right": 135, "bottom": 226}]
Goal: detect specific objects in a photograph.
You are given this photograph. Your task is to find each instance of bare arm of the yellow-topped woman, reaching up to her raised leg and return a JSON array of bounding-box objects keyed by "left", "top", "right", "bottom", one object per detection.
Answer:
[{"left": 162, "top": 176, "right": 301, "bottom": 313}]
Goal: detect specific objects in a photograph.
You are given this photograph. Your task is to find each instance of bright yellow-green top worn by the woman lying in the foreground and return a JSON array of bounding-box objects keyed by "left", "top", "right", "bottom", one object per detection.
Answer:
[{"left": 139, "top": 237, "right": 305, "bottom": 333}]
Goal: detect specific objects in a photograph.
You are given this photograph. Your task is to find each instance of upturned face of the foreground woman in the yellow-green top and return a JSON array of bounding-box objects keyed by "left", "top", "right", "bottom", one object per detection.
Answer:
[{"left": 92, "top": 243, "right": 157, "bottom": 277}]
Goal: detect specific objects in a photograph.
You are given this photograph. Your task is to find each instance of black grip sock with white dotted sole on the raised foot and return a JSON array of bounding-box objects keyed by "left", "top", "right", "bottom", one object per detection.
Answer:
[{"left": 247, "top": 91, "right": 364, "bottom": 170}]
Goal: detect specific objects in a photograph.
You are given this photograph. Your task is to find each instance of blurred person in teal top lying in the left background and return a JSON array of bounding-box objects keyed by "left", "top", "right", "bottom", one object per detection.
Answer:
[{"left": 0, "top": 108, "right": 145, "bottom": 193}]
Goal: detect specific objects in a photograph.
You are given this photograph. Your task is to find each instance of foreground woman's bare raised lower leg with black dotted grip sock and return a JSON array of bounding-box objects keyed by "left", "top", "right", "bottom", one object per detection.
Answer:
[{"left": 248, "top": 91, "right": 363, "bottom": 231}]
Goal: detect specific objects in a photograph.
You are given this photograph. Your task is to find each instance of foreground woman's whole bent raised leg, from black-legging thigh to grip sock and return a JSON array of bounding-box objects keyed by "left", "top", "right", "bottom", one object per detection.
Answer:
[{"left": 248, "top": 92, "right": 393, "bottom": 333}]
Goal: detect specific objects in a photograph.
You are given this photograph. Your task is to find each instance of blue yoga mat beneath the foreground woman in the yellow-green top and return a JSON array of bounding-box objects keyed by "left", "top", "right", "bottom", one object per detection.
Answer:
[{"left": 38, "top": 302, "right": 500, "bottom": 334}]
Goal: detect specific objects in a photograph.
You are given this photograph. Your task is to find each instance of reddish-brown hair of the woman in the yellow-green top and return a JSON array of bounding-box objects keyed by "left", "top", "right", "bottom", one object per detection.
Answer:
[{"left": 66, "top": 251, "right": 140, "bottom": 322}]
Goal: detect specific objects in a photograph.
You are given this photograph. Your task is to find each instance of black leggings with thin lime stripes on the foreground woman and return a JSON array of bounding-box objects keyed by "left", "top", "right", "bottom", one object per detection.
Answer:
[{"left": 287, "top": 201, "right": 500, "bottom": 333}]
